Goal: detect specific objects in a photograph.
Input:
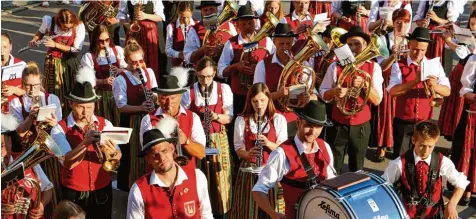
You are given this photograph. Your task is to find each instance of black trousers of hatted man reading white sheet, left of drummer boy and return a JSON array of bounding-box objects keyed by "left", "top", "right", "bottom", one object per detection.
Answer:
[{"left": 393, "top": 118, "right": 416, "bottom": 159}]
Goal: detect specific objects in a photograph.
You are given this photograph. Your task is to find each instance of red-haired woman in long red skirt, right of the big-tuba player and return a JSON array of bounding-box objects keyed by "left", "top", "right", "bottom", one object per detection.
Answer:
[{"left": 371, "top": 8, "right": 411, "bottom": 162}]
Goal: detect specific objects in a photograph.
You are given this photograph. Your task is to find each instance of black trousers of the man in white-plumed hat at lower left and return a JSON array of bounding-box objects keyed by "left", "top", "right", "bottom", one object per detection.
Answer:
[{"left": 61, "top": 183, "right": 112, "bottom": 219}]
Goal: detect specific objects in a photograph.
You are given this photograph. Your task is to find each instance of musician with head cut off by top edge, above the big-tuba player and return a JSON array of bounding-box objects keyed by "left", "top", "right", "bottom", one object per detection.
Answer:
[{"left": 332, "top": 0, "right": 377, "bottom": 33}]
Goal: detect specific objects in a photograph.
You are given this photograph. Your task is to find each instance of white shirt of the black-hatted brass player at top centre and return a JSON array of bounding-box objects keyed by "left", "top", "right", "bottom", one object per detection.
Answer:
[{"left": 218, "top": 33, "right": 276, "bottom": 79}]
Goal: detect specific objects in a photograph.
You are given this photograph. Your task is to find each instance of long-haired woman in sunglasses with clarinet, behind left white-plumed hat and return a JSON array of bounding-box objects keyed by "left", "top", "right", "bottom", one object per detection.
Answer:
[{"left": 81, "top": 24, "right": 127, "bottom": 126}]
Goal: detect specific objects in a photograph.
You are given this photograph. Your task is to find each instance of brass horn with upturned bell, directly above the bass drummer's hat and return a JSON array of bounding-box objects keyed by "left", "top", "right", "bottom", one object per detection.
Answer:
[{"left": 276, "top": 33, "right": 328, "bottom": 112}]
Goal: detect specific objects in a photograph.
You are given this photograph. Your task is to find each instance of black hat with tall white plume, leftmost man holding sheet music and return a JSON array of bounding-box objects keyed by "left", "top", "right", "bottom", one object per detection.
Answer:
[{"left": 65, "top": 67, "right": 101, "bottom": 103}]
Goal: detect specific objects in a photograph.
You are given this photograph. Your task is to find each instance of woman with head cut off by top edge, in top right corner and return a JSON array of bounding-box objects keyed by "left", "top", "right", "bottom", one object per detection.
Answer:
[{"left": 413, "top": 0, "right": 463, "bottom": 60}]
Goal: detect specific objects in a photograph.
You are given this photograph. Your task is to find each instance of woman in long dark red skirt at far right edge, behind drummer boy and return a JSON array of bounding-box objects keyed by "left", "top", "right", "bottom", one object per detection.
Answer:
[{"left": 438, "top": 11, "right": 476, "bottom": 141}]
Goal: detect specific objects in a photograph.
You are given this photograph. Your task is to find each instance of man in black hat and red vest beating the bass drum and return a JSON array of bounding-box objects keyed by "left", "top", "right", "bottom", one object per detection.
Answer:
[{"left": 253, "top": 100, "right": 336, "bottom": 219}]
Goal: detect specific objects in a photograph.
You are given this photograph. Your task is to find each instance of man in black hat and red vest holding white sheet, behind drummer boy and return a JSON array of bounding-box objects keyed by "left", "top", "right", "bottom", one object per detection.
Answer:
[{"left": 387, "top": 27, "right": 450, "bottom": 158}]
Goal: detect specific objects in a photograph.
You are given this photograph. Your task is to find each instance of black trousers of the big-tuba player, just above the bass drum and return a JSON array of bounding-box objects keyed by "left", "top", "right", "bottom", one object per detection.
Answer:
[{"left": 331, "top": 122, "right": 370, "bottom": 174}]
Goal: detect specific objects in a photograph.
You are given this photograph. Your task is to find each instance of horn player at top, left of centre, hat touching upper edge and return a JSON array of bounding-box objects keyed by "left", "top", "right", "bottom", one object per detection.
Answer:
[{"left": 183, "top": 1, "right": 237, "bottom": 64}]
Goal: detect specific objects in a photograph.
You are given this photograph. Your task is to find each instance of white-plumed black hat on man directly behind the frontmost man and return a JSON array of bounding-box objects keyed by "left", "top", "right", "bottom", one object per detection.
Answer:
[{"left": 152, "top": 67, "right": 189, "bottom": 95}]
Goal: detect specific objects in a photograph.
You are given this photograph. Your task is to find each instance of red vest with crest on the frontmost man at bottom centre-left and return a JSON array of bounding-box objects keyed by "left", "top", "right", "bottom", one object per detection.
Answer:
[{"left": 136, "top": 166, "right": 201, "bottom": 219}]
